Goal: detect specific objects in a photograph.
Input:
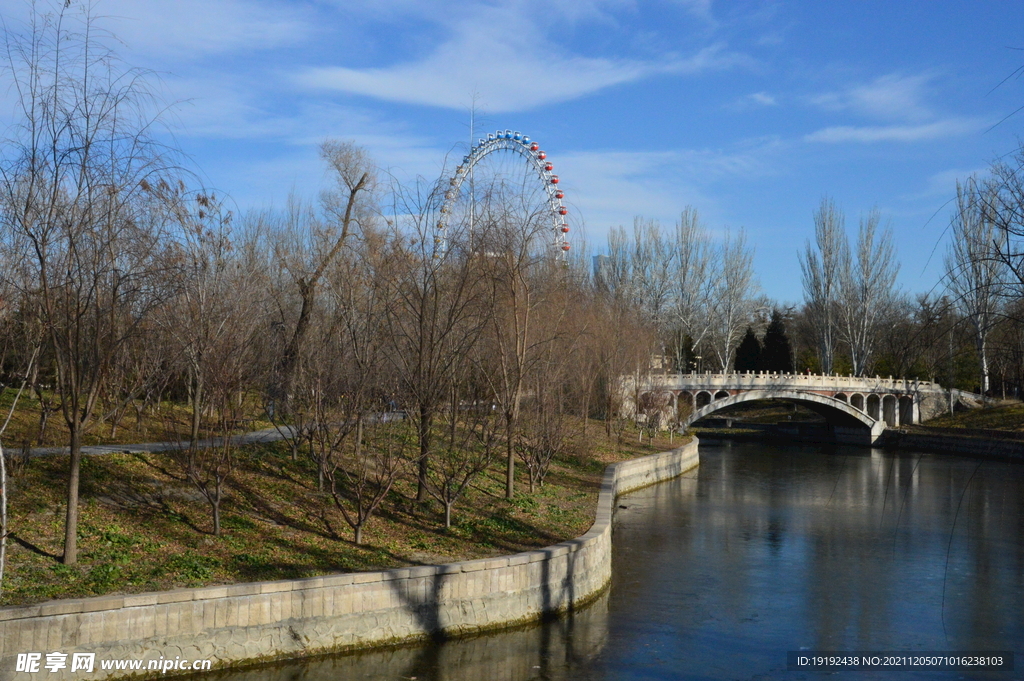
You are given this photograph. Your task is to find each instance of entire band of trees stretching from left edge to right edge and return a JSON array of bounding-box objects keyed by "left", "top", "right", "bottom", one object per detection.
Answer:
[{"left": 0, "top": 1, "right": 1024, "bottom": 585}]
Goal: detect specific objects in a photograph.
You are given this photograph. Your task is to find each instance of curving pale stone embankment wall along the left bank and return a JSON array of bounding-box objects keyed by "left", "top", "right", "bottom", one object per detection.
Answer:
[{"left": 0, "top": 438, "right": 698, "bottom": 681}]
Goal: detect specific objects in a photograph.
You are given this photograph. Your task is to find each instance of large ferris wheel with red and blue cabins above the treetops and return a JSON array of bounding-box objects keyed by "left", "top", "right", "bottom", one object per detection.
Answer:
[{"left": 434, "top": 130, "right": 569, "bottom": 258}]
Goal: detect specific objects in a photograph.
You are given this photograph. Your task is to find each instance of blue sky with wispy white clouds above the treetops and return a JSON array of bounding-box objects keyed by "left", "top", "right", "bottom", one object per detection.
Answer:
[{"left": 6, "top": 0, "right": 1024, "bottom": 302}]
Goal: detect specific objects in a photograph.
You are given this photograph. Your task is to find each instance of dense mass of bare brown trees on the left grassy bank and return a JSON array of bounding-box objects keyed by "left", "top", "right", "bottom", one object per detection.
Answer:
[{"left": 0, "top": 4, "right": 654, "bottom": 564}]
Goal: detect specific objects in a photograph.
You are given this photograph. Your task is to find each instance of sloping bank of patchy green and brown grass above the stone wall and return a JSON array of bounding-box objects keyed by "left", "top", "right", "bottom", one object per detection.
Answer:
[{"left": 0, "top": 422, "right": 683, "bottom": 605}]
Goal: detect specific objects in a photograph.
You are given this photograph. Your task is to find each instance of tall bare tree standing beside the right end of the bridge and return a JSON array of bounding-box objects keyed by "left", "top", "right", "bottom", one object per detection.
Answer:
[{"left": 945, "top": 177, "right": 1007, "bottom": 395}]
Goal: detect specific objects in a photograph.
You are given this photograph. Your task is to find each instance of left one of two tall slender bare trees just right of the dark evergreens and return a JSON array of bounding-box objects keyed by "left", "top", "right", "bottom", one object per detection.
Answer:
[{"left": 800, "top": 198, "right": 850, "bottom": 374}]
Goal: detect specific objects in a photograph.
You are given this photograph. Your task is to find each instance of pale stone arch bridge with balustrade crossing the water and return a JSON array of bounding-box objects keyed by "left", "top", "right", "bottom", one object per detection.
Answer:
[{"left": 623, "top": 372, "right": 946, "bottom": 443}]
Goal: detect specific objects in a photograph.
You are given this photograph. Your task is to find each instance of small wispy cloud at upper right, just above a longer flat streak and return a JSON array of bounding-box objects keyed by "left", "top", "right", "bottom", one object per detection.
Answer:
[{"left": 811, "top": 74, "right": 933, "bottom": 122}]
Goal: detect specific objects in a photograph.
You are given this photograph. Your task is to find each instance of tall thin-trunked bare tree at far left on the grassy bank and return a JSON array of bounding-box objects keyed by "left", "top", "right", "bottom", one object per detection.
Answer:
[{"left": 0, "top": 3, "right": 176, "bottom": 564}]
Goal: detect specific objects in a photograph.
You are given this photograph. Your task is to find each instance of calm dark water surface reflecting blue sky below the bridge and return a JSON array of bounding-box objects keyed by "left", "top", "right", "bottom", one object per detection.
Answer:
[{"left": 224, "top": 443, "right": 1024, "bottom": 681}]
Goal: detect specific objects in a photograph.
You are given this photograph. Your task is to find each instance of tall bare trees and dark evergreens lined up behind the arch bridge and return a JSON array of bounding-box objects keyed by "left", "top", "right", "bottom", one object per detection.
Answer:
[{"left": 595, "top": 178, "right": 1024, "bottom": 395}]
